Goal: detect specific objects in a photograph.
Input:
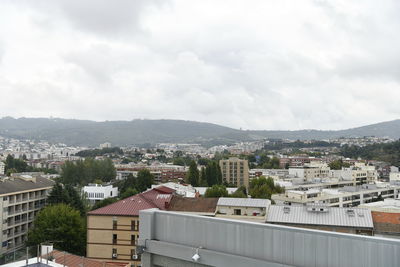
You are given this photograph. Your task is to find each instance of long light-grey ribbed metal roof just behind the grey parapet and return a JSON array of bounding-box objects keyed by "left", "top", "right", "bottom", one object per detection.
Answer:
[{"left": 267, "top": 205, "right": 374, "bottom": 228}]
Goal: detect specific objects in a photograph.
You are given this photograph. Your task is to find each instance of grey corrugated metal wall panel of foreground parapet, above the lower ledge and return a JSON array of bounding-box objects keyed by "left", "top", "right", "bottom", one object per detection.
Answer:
[{"left": 140, "top": 210, "right": 400, "bottom": 267}]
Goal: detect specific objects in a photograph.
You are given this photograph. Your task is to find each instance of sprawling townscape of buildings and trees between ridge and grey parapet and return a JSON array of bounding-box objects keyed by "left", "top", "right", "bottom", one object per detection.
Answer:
[{"left": 0, "top": 137, "right": 400, "bottom": 266}]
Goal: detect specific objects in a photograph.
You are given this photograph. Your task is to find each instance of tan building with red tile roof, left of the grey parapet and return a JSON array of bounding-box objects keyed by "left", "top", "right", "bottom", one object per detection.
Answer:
[{"left": 86, "top": 187, "right": 175, "bottom": 266}]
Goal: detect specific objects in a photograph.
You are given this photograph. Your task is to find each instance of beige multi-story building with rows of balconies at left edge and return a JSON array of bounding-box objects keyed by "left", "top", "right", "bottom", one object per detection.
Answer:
[{"left": 0, "top": 175, "right": 54, "bottom": 255}]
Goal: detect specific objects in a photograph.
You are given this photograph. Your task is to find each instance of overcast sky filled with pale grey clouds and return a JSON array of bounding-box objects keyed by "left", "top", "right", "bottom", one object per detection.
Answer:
[{"left": 0, "top": 0, "right": 400, "bottom": 129}]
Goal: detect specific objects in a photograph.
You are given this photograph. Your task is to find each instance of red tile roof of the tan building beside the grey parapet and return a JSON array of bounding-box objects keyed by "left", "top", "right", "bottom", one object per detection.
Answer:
[{"left": 88, "top": 186, "right": 175, "bottom": 216}]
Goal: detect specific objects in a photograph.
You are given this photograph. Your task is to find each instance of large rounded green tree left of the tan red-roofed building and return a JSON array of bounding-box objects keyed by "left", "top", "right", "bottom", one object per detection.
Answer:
[{"left": 27, "top": 204, "right": 86, "bottom": 256}]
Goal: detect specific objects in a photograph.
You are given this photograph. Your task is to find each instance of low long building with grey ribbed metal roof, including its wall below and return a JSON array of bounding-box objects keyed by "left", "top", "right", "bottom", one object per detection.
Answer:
[{"left": 267, "top": 205, "right": 374, "bottom": 235}]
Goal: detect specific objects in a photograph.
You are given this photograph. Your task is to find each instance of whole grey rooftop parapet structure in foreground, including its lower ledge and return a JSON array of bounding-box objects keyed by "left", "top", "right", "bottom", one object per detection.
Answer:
[{"left": 139, "top": 209, "right": 400, "bottom": 267}]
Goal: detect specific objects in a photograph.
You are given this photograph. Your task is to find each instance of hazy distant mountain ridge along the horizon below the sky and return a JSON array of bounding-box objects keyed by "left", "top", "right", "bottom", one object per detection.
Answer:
[{"left": 0, "top": 117, "right": 400, "bottom": 146}]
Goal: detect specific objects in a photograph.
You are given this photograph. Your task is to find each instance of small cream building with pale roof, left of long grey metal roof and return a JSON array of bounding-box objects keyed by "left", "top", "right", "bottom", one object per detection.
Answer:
[{"left": 215, "top": 197, "right": 271, "bottom": 222}]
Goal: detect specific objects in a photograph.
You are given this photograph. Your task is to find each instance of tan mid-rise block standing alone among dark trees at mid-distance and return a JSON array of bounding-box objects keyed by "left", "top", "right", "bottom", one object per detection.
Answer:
[{"left": 219, "top": 158, "right": 249, "bottom": 187}]
